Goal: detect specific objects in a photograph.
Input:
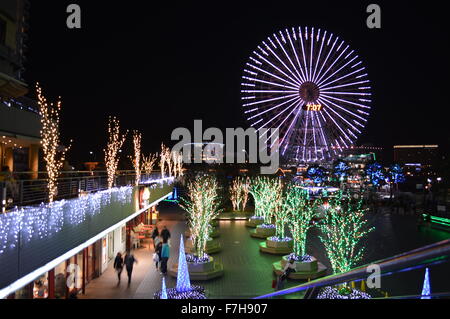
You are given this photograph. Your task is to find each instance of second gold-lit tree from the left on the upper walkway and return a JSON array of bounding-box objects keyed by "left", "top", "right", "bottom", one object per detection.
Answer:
[{"left": 103, "top": 116, "right": 127, "bottom": 188}]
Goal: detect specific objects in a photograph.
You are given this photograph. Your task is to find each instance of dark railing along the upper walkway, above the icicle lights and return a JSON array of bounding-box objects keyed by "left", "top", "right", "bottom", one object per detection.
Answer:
[{"left": 0, "top": 171, "right": 160, "bottom": 209}]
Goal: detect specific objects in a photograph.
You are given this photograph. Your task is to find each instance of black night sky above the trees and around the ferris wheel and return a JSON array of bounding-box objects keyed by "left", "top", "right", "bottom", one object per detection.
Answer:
[{"left": 25, "top": 0, "right": 450, "bottom": 166}]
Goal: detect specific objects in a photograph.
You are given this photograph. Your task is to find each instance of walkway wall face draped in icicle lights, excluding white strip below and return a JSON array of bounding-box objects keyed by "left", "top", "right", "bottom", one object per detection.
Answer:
[{"left": 0, "top": 183, "right": 172, "bottom": 289}]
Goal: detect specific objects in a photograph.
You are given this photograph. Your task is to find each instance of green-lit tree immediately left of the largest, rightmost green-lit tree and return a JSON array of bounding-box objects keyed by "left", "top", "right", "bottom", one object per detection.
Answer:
[{"left": 283, "top": 184, "right": 319, "bottom": 257}]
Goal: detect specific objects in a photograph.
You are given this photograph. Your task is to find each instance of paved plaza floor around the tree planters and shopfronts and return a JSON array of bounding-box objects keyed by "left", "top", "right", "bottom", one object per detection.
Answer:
[{"left": 80, "top": 203, "right": 450, "bottom": 299}]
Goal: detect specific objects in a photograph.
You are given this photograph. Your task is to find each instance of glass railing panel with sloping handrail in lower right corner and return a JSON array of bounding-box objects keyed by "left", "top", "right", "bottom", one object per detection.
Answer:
[{"left": 257, "top": 240, "right": 450, "bottom": 299}]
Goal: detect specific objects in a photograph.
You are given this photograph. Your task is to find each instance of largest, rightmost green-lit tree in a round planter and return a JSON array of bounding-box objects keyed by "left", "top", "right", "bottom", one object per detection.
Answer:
[{"left": 319, "top": 192, "right": 374, "bottom": 273}]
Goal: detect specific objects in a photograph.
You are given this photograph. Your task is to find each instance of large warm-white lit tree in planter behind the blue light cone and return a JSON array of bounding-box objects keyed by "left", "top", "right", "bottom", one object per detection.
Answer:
[{"left": 181, "top": 175, "right": 220, "bottom": 258}]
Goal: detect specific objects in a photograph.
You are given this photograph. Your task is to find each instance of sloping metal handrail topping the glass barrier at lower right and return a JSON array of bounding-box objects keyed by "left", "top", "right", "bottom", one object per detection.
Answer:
[{"left": 255, "top": 239, "right": 450, "bottom": 299}]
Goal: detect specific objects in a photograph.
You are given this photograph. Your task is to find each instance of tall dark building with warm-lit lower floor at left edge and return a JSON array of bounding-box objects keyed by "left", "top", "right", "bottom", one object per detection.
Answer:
[{"left": 0, "top": 0, "right": 41, "bottom": 178}]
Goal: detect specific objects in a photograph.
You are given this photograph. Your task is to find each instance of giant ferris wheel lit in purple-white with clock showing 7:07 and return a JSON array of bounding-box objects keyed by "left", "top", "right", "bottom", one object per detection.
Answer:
[{"left": 241, "top": 27, "right": 371, "bottom": 162}]
